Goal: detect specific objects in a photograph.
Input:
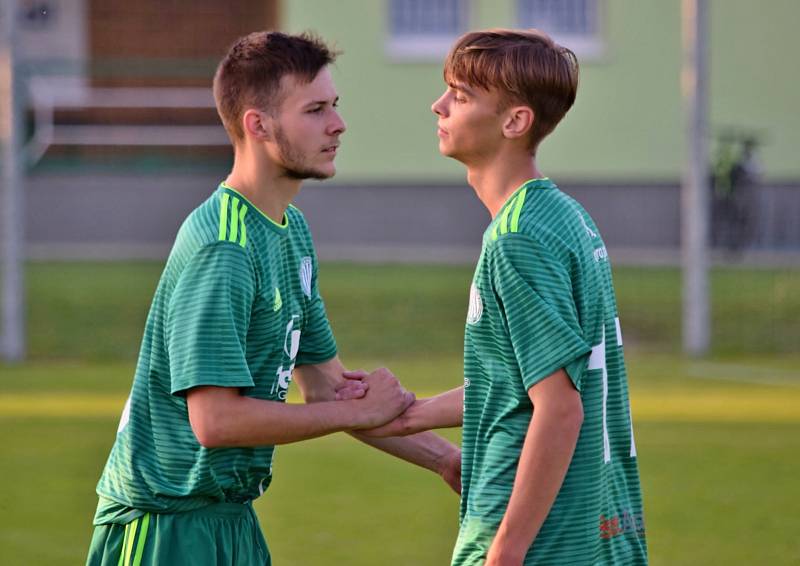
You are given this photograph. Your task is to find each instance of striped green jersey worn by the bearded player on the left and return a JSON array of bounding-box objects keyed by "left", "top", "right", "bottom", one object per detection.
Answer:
[{"left": 95, "top": 184, "right": 336, "bottom": 524}]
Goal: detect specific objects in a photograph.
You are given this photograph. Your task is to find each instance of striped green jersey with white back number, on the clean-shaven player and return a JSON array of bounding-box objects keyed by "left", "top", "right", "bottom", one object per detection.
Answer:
[{"left": 453, "top": 179, "right": 647, "bottom": 566}]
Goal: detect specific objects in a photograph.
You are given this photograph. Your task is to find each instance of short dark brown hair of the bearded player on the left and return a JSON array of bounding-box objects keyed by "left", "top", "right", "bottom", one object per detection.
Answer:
[{"left": 214, "top": 31, "right": 338, "bottom": 143}]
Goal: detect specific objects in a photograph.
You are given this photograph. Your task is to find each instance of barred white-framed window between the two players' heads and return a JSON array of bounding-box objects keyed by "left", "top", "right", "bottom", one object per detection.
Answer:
[{"left": 386, "top": 0, "right": 469, "bottom": 60}]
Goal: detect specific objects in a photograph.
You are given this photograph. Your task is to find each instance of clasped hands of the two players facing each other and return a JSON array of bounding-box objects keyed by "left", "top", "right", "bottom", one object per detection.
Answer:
[{"left": 336, "top": 368, "right": 418, "bottom": 437}]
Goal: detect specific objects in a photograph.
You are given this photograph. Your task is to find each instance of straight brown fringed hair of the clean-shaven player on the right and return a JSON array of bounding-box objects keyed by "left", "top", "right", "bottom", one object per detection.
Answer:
[{"left": 444, "top": 29, "right": 578, "bottom": 153}]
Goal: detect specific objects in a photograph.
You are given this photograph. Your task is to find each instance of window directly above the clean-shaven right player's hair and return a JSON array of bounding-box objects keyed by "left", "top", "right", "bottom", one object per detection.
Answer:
[{"left": 517, "top": 0, "right": 604, "bottom": 58}]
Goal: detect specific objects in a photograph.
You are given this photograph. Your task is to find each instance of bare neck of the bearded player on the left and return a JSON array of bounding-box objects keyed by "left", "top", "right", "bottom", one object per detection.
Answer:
[{"left": 225, "top": 151, "right": 302, "bottom": 224}]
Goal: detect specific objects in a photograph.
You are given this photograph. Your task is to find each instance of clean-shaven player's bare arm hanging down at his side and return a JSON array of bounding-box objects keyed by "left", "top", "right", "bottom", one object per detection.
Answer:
[{"left": 486, "top": 369, "right": 583, "bottom": 566}]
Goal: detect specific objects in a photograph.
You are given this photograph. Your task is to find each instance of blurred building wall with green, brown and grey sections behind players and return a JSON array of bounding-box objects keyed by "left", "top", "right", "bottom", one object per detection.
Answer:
[{"left": 10, "top": 0, "right": 800, "bottom": 262}]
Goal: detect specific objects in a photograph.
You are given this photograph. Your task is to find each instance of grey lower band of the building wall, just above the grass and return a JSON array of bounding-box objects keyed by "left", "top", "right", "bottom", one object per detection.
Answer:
[{"left": 26, "top": 175, "right": 800, "bottom": 265}]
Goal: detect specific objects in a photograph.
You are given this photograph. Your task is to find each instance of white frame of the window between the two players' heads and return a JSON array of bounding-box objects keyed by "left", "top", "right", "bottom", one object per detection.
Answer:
[{"left": 385, "top": 0, "right": 473, "bottom": 62}]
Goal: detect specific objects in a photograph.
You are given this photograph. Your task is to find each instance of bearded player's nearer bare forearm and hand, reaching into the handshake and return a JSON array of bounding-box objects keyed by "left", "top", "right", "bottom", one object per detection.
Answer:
[{"left": 186, "top": 362, "right": 414, "bottom": 448}]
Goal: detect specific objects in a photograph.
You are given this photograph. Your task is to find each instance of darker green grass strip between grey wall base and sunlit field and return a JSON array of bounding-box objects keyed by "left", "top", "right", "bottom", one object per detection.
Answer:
[{"left": 21, "top": 262, "right": 800, "bottom": 360}]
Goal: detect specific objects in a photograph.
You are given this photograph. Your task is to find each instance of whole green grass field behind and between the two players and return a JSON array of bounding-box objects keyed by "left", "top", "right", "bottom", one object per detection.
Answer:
[{"left": 0, "top": 263, "right": 800, "bottom": 566}]
